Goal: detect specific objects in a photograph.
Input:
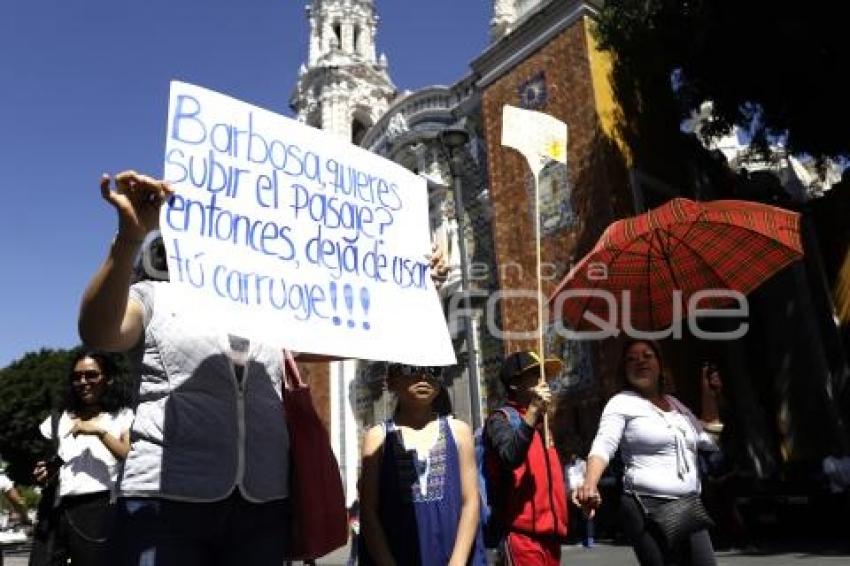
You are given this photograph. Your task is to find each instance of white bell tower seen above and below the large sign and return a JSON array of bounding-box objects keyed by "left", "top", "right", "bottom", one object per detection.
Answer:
[{"left": 290, "top": 0, "right": 396, "bottom": 503}]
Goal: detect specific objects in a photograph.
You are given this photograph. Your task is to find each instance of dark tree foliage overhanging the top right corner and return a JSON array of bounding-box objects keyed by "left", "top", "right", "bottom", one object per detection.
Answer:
[{"left": 598, "top": 0, "right": 850, "bottom": 158}]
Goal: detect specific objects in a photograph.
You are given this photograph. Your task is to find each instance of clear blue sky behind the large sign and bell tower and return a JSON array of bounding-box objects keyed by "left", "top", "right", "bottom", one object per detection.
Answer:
[{"left": 0, "top": 0, "right": 491, "bottom": 367}]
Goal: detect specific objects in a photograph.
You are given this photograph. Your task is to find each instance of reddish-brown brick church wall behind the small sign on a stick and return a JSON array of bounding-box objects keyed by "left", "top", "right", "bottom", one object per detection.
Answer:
[{"left": 482, "top": 19, "right": 630, "bottom": 360}]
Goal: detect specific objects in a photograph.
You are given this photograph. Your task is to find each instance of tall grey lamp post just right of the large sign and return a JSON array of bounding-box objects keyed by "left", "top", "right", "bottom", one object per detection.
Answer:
[{"left": 440, "top": 127, "right": 481, "bottom": 429}]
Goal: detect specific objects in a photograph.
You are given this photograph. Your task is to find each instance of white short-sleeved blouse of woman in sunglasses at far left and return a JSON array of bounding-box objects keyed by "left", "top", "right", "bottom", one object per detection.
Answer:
[{"left": 38, "top": 409, "right": 133, "bottom": 498}]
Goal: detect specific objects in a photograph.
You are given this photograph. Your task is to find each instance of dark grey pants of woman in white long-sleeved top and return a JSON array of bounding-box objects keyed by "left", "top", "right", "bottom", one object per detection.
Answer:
[{"left": 620, "top": 493, "right": 717, "bottom": 566}]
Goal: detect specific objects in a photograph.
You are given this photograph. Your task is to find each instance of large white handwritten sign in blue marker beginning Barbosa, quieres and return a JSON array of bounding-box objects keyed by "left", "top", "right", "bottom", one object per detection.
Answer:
[{"left": 160, "top": 81, "right": 455, "bottom": 365}]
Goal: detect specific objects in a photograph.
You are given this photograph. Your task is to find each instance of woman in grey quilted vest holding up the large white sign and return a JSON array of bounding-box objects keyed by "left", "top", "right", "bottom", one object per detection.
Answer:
[{"left": 79, "top": 171, "right": 450, "bottom": 566}]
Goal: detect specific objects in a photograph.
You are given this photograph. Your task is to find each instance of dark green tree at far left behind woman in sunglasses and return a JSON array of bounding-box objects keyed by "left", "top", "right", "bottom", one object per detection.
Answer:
[{"left": 0, "top": 349, "right": 128, "bottom": 484}]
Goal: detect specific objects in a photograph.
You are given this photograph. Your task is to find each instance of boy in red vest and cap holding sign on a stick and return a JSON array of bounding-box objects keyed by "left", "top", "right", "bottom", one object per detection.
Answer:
[{"left": 486, "top": 351, "right": 567, "bottom": 566}]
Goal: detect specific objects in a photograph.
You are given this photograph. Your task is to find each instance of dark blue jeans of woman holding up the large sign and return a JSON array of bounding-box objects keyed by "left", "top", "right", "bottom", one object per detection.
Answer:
[{"left": 115, "top": 491, "right": 289, "bottom": 566}]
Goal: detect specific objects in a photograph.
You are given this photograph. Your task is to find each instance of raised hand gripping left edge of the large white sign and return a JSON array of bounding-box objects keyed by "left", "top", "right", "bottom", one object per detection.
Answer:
[{"left": 100, "top": 170, "right": 173, "bottom": 243}]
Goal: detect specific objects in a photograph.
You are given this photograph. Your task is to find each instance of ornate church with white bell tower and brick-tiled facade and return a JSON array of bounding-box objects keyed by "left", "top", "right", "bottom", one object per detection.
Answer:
[{"left": 293, "top": 0, "right": 847, "bottom": 508}]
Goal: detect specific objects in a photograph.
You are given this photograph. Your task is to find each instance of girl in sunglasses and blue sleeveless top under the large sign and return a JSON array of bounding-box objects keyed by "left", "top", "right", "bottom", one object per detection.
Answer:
[{"left": 358, "top": 364, "right": 486, "bottom": 566}]
